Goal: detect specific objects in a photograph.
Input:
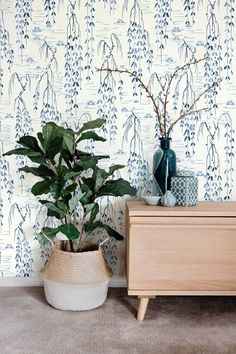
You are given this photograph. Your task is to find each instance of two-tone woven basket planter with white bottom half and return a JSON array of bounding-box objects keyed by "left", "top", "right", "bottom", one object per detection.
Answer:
[{"left": 41, "top": 241, "right": 112, "bottom": 311}]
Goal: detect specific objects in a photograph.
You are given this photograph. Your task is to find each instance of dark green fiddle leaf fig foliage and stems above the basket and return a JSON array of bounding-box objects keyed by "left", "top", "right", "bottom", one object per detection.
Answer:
[{"left": 4, "top": 119, "right": 136, "bottom": 252}]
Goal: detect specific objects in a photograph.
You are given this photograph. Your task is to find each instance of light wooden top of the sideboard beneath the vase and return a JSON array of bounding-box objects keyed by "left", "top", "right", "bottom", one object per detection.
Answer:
[{"left": 126, "top": 200, "right": 236, "bottom": 217}]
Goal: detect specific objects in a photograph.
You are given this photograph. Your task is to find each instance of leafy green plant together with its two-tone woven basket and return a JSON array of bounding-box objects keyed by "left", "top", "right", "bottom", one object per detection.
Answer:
[{"left": 5, "top": 119, "right": 136, "bottom": 310}]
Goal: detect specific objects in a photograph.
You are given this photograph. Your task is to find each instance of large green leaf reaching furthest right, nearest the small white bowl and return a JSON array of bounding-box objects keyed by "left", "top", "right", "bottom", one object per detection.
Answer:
[{"left": 97, "top": 178, "right": 136, "bottom": 197}]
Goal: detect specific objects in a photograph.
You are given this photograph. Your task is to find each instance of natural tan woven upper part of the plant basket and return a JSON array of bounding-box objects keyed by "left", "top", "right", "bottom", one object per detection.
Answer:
[{"left": 41, "top": 241, "right": 112, "bottom": 285}]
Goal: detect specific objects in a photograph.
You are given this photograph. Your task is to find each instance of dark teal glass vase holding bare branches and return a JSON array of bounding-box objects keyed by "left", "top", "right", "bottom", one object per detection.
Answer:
[{"left": 153, "top": 137, "right": 176, "bottom": 194}]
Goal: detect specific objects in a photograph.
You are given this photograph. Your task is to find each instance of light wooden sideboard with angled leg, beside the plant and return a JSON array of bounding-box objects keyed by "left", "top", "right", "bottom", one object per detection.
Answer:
[{"left": 126, "top": 200, "right": 236, "bottom": 321}]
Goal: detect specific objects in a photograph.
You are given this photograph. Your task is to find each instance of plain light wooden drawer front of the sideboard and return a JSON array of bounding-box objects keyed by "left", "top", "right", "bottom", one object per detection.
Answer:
[{"left": 128, "top": 223, "right": 236, "bottom": 291}]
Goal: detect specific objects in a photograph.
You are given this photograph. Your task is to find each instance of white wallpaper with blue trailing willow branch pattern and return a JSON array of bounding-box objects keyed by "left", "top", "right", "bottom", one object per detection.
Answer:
[{"left": 0, "top": 0, "right": 236, "bottom": 277}]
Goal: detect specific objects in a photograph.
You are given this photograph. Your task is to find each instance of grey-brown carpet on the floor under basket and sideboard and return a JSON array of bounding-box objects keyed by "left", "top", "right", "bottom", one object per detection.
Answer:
[{"left": 0, "top": 288, "right": 236, "bottom": 354}]
